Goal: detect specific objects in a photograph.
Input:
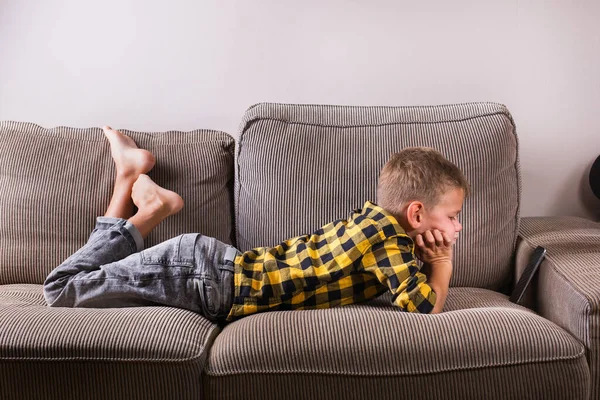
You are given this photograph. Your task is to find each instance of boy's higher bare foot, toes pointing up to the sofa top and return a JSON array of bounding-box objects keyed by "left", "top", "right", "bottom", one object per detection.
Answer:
[{"left": 102, "top": 126, "right": 155, "bottom": 179}]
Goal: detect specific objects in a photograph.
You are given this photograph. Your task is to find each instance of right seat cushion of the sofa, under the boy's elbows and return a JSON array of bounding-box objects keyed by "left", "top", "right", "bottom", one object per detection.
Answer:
[{"left": 204, "top": 288, "right": 589, "bottom": 399}]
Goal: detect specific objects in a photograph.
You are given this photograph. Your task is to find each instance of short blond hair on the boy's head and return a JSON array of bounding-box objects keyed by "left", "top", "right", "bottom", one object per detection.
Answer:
[{"left": 377, "top": 147, "right": 469, "bottom": 215}]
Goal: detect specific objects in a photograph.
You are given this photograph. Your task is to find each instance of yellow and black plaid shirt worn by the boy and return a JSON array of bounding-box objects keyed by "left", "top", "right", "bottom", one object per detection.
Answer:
[{"left": 227, "top": 202, "right": 436, "bottom": 321}]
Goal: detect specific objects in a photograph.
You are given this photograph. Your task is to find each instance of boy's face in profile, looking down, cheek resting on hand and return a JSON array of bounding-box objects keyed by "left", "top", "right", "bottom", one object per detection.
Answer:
[{"left": 417, "top": 188, "right": 465, "bottom": 241}]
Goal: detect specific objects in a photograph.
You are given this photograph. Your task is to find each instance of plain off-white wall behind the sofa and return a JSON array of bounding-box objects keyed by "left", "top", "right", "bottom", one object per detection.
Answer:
[{"left": 0, "top": 0, "right": 600, "bottom": 219}]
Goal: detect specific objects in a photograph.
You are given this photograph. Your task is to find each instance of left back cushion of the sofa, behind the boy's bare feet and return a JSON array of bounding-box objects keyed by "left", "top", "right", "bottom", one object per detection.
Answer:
[{"left": 0, "top": 122, "right": 235, "bottom": 284}]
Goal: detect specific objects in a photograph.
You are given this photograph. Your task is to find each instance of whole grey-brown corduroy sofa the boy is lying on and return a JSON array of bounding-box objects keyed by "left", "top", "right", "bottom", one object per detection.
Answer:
[{"left": 0, "top": 103, "right": 600, "bottom": 399}]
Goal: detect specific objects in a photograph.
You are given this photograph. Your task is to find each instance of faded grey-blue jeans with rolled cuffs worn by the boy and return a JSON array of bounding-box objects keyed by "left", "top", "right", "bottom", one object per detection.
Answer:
[{"left": 44, "top": 217, "right": 239, "bottom": 321}]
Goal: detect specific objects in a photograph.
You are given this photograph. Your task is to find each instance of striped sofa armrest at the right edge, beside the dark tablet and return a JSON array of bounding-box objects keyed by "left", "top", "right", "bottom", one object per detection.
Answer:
[{"left": 516, "top": 217, "right": 600, "bottom": 399}]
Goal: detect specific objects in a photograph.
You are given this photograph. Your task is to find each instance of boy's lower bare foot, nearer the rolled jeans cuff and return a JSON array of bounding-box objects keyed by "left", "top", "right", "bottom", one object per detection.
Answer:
[{"left": 131, "top": 174, "right": 183, "bottom": 220}]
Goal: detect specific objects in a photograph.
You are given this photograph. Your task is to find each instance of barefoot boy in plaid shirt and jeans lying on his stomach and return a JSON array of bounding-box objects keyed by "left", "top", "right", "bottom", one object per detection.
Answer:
[{"left": 44, "top": 127, "right": 469, "bottom": 321}]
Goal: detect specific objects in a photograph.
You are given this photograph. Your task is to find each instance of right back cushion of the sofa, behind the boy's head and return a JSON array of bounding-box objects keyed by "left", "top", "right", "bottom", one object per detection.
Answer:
[{"left": 235, "top": 103, "right": 520, "bottom": 290}]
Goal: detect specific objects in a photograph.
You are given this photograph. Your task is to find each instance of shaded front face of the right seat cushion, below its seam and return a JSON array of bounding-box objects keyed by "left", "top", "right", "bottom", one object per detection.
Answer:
[{"left": 205, "top": 366, "right": 587, "bottom": 400}]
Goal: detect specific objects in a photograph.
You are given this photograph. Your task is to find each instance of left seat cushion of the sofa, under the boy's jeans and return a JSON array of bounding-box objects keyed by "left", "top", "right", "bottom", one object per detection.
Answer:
[{"left": 0, "top": 284, "right": 219, "bottom": 400}]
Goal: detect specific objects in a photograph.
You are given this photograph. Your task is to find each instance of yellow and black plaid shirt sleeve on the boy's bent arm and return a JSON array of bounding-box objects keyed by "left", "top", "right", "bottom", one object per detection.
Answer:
[{"left": 363, "top": 237, "right": 436, "bottom": 314}]
